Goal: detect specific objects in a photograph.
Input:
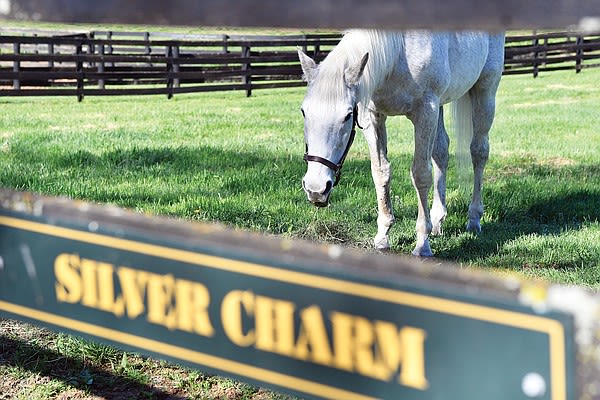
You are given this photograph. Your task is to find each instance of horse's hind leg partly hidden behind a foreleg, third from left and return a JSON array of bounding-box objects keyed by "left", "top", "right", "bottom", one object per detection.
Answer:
[{"left": 431, "top": 107, "right": 449, "bottom": 235}]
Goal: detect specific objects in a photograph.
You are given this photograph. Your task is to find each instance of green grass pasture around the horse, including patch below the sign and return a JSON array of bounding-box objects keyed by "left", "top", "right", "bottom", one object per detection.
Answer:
[{"left": 0, "top": 65, "right": 600, "bottom": 400}]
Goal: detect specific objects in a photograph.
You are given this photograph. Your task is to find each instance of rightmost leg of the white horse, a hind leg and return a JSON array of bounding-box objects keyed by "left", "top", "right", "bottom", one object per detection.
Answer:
[{"left": 467, "top": 85, "right": 497, "bottom": 233}]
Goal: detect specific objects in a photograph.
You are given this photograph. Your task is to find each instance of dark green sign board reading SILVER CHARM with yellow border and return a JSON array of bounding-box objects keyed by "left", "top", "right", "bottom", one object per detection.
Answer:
[{"left": 0, "top": 192, "right": 575, "bottom": 400}]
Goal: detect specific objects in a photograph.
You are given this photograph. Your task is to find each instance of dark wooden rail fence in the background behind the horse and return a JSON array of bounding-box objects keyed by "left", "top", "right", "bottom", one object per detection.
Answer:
[{"left": 0, "top": 31, "right": 600, "bottom": 101}]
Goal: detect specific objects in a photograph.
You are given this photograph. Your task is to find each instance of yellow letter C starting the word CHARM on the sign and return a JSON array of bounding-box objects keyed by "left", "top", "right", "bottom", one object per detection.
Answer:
[{"left": 221, "top": 290, "right": 254, "bottom": 347}]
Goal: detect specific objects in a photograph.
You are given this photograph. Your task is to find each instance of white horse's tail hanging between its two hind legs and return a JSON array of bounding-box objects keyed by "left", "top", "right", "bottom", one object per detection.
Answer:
[{"left": 451, "top": 92, "right": 473, "bottom": 191}]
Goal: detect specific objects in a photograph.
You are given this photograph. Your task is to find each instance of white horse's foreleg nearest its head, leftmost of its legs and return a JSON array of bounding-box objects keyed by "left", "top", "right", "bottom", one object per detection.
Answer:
[{"left": 363, "top": 112, "right": 394, "bottom": 250}]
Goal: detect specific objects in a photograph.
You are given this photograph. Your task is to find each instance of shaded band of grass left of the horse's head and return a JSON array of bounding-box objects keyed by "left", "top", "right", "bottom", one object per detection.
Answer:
[{"left": 4, "top": 146, "right": 304, "bottom": 207}]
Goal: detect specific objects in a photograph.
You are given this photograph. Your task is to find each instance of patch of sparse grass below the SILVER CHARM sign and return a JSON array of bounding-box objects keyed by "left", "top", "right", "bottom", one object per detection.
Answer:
[{"left": 0, "top": 320, "right": 284, "bottom": 400}]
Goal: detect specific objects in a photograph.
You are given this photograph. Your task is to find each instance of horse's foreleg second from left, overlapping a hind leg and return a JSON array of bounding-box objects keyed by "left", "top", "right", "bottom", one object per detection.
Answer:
[{"left": 409, "top": 96, "right": 440, "bottom": 257}]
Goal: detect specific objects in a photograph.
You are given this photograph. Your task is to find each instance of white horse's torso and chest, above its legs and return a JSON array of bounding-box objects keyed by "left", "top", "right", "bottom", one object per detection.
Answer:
[{"left": 372, "top": 31, "right": 504, "bottom": 115}]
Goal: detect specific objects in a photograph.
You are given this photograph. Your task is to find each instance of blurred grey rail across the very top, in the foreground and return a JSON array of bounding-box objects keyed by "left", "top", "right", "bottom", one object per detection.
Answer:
[{"left": 0, "top": 0, "right": 600, "bottom": 30}]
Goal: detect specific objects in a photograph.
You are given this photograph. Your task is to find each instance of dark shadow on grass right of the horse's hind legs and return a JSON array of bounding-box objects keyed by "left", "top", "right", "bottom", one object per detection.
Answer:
[{"left": 435, "top": 165, "right": 600, "bottom": 269}]
